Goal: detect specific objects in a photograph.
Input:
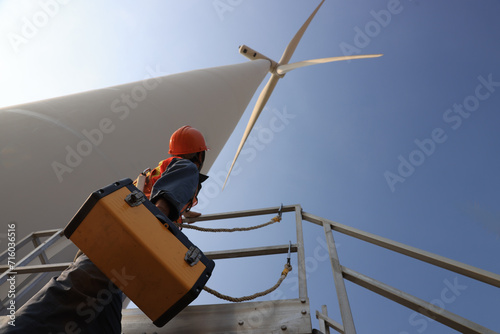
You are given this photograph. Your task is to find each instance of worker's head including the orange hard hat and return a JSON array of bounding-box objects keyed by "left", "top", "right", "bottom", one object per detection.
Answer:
[{"left": 168, "top": 125, "right": 208, "bottom": 170}]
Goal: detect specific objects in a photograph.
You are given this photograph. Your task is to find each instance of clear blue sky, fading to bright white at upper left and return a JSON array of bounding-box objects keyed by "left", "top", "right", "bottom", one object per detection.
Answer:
[{"left": 0, "top": 0, "right": 500, "bottom": 334}]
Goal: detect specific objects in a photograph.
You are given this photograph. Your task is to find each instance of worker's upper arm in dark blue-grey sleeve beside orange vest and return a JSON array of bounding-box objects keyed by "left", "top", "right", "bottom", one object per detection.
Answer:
[{"left": 151, "top": 159, "right": 199, "bottom": 221}]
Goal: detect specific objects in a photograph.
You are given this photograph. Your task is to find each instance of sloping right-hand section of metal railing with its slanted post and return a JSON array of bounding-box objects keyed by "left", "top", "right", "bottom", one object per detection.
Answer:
[{"left": 302, "top": 213, "right": 500, "bottom": 334}]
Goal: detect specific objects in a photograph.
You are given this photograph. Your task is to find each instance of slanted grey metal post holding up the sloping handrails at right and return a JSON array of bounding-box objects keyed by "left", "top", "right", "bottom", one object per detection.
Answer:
[{"left": 323, "top": 222, "right": 356, "bottom": 334}]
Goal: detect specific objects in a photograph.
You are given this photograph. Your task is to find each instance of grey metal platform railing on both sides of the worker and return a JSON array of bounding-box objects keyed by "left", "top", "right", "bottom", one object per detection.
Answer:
[{"left": 0, "top": 205, "right": 500, "bottom": 334}]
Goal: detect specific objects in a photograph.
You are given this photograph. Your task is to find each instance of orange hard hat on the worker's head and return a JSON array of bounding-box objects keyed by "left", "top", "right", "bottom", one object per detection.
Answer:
[{"left": 168, "top": 125, "right": 208, "bottom": 155}]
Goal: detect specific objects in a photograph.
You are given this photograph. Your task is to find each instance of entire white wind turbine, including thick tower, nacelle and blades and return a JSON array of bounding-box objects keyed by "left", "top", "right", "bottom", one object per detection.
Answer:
[{"left": 0, "top": 1, "right": 378, "bottom": 261}]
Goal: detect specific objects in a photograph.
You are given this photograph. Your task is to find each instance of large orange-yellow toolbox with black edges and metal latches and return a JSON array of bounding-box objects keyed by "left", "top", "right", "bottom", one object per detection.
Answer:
[{"left": 64, "top": 179, "right": 214, "bottom": 327}]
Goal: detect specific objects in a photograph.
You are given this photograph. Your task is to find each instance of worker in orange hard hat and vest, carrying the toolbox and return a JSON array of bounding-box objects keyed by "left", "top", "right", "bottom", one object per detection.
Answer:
[{"left": 0, "top": 126, "right": 207, "bottom": 334}]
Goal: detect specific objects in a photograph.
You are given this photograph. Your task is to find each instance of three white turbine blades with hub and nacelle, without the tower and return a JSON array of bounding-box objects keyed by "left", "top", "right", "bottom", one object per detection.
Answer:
[{"left": 222, "top": 0, "right": 382, "bottom": 189}]
